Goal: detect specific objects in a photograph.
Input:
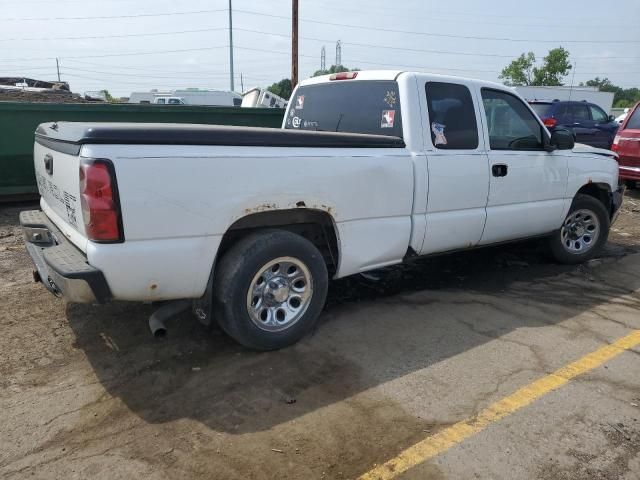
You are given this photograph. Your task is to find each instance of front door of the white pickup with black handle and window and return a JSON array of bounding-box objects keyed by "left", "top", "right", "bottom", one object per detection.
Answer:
[{"left": 478, "top": 87, "right": 568, "bottom": 245}]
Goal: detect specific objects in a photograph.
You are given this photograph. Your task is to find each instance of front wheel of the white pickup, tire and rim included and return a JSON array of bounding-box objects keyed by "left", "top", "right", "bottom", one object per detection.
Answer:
[{"left": 550, "top": 193, "right": 610, "bottom": 264}]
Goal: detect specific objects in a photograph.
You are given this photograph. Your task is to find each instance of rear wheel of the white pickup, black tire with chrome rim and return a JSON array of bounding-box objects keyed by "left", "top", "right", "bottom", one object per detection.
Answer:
[{"left": 213, "top": 230, "right": 329, "bottom": 351}]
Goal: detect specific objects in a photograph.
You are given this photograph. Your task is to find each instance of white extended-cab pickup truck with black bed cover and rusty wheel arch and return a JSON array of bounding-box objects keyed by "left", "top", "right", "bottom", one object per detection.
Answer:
[{"left": 20, "top": 71, "right": 623, "bottom": 350}]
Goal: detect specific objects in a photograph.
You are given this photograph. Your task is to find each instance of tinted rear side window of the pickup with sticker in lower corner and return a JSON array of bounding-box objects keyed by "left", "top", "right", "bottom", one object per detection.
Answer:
[{"left": 425, "top": 82, "right": 478, "bottom": 150}]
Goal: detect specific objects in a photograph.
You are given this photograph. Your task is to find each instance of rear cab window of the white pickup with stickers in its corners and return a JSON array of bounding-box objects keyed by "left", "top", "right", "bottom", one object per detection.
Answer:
[{"left": 285, "top": 80, "right": 402, "bottom": 137}]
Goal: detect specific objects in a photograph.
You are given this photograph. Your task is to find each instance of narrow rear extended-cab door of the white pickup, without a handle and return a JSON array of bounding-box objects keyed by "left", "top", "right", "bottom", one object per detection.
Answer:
[{"left": 418, "top": 80, "right": 489, "bottom": 255}]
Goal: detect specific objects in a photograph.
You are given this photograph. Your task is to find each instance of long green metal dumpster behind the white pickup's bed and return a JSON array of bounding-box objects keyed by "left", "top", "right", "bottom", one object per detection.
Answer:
[{"left": 0, "top": 102, "right": 284, "bottom": 200}]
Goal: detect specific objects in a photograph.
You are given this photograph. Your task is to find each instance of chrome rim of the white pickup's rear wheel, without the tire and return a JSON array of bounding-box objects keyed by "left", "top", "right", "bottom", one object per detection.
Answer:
[{"left": 247, "top": 257, "right": 313, "bottom": 332}]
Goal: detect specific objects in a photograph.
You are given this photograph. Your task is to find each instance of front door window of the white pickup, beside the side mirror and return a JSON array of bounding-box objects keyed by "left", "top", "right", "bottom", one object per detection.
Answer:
[{"left": 482, "top": 88, "right": 543, "bottom": 150}]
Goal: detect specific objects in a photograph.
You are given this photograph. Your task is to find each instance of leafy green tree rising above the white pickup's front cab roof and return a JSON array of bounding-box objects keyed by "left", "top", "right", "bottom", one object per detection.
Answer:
[{"left": 498, "top": 47, "right": 571, "bottom": 86}]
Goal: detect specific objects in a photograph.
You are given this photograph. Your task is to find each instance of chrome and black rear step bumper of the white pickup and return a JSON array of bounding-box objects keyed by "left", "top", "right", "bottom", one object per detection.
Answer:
[{"left": 20, "top": 210, "right": 111, "bottom": 303}]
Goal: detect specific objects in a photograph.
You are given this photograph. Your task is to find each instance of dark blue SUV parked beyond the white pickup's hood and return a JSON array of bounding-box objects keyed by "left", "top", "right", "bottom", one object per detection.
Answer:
[{"left": 529, "top": 100, "right": 618, "bottom": 149}]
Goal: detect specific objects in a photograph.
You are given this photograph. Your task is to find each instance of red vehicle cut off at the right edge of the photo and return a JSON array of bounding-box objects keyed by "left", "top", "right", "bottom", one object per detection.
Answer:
[{"left": 611, "top": 102, "right": 640, "bottom": 188}]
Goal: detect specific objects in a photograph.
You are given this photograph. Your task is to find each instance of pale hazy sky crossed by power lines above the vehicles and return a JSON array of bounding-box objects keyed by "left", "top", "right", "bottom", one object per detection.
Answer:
[{"left": 0, "top": 0, "right": 640, "bottom": 96}]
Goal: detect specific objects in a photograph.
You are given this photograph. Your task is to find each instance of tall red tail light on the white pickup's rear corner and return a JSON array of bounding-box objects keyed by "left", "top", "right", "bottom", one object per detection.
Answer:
[{"left": 80, "top": 159, "right": 124, "bottom": 243}]
